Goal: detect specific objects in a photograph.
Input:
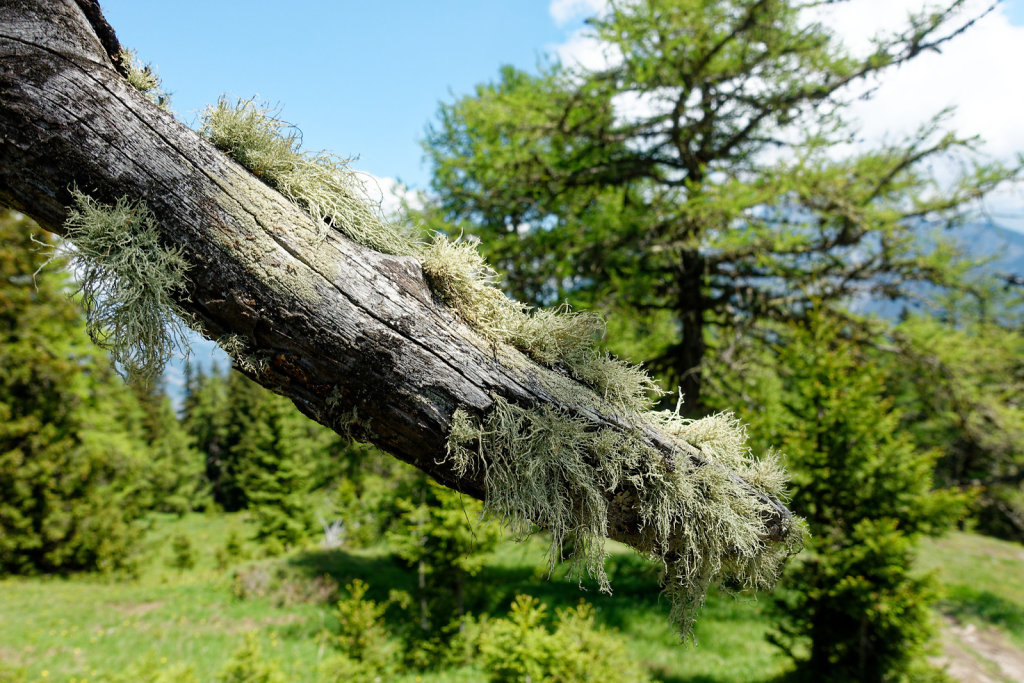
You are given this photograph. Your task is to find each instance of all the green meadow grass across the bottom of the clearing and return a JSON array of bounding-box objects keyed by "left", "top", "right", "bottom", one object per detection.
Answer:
[{"left": 0, "top": 514, "right": 1024, "bottom": 683}]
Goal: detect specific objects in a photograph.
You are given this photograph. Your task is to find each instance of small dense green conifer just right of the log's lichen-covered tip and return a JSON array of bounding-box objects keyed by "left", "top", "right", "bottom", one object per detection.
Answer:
[{"left": 759, "top": 312, "right": 964, "bottom": 681}]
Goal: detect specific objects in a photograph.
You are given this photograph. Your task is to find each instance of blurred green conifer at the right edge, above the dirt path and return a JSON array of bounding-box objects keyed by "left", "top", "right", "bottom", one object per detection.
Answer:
[{"left": 892, "top": 317, "right": 1024, "bottom": 542}]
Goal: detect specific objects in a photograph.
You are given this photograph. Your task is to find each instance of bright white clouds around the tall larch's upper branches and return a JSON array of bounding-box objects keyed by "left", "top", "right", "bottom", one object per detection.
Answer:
[{"left": 551, "top": 0, "right": 1024, "bottom": 229}]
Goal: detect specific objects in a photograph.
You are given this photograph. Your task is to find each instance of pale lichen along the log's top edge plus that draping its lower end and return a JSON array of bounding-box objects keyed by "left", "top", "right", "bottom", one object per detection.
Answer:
[{"left": 202, "top": 98, "right": 804, "bottom": 635}]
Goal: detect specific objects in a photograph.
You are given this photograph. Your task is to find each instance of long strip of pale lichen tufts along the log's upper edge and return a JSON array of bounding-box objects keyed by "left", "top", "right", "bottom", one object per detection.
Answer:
[{"left": 201, "top": 97, "right": 660, "bottom": 410}]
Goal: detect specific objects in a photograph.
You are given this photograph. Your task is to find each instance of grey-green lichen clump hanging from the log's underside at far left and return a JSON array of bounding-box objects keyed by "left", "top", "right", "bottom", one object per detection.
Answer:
[{"left": 48, "top": 189, "right": 188, "bottom": 383}]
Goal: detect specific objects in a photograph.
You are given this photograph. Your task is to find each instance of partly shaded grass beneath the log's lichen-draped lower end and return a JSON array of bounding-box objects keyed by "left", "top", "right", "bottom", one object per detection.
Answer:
[{"left": 291, "top": 538, "right": 788, "bottom": 682}]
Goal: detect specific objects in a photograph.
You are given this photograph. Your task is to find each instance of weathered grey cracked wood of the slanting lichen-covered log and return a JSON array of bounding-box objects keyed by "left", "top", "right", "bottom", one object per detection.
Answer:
[{"left": 0, "top": 0, "right": 791, "bottom": 545}]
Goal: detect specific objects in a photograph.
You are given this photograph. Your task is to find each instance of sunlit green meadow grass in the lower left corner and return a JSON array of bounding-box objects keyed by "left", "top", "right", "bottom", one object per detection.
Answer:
[{"left": 0, "top": 515, "right": 322, "bottom": 683}]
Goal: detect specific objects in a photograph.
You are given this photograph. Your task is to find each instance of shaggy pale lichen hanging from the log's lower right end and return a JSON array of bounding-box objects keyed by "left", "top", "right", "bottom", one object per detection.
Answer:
[{"left": 449, "top": 397, "right": 802, "bottom": 635}]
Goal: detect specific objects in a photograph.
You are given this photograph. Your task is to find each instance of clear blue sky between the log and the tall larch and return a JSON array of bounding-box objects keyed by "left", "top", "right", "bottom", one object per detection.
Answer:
[{"left": 100, "top": 0, "right": 580, "bottom": 187}]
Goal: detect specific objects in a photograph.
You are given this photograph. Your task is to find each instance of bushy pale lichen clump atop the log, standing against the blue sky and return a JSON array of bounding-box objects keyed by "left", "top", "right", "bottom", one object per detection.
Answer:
[{"left": 200, "top": 97, "right": 415, "bottom": 255}]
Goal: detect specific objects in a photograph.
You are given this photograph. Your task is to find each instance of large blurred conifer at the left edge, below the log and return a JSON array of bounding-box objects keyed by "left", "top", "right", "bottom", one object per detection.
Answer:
[{"left": 0, "top": 213, "right": 145, "bottom": 573}]
